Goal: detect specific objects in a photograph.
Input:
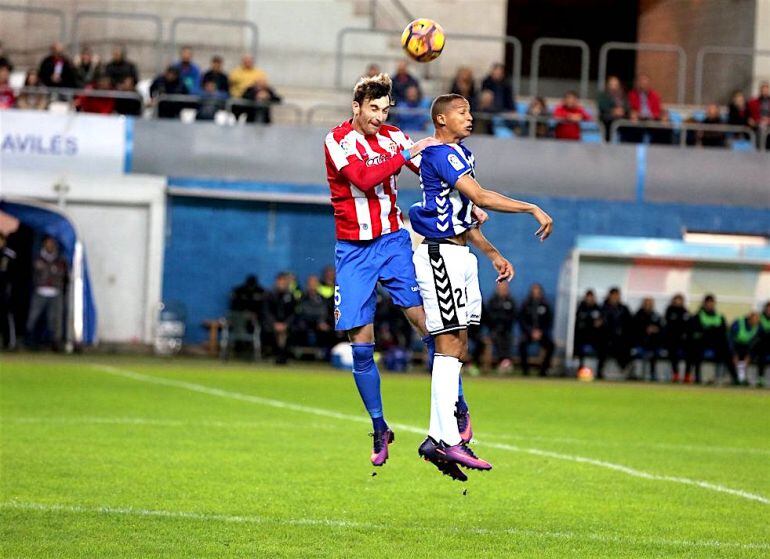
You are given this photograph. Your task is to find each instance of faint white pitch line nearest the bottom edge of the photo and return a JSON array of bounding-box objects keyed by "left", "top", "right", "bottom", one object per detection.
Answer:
[{"left": 0, "top": 501, "right": 770, "bottom": 550}]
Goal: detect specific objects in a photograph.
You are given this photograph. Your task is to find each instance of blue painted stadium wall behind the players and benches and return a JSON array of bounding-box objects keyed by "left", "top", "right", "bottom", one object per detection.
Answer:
[{"left": 163, "top": 184, "right": 770, "bottom": 342}]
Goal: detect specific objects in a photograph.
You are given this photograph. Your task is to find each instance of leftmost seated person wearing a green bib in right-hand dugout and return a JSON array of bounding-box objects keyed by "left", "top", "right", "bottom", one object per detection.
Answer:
[{"left": 684, "top": 295, "right": 738, "bottom": 384}]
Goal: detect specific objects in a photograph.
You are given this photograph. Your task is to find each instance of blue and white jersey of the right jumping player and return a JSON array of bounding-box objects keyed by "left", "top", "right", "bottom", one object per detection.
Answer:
[{"left": 409, "top": 144, "right": 476, "bottom": 239}]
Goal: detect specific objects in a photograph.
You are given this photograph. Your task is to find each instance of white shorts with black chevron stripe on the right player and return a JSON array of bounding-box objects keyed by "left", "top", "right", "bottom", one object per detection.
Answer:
[{"left": 414, "top": 242, "right": 481, "bottom": 335}]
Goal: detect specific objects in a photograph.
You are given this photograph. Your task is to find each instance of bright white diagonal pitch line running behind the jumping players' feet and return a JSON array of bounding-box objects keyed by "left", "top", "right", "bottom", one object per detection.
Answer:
[{"left": 93, "top": 365, "right": 770, "bottom": 505}]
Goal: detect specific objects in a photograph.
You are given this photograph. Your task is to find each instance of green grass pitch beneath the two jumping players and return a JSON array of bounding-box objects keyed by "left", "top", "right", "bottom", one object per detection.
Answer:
[{"left": 0, "top": 355, "right": 770, "bottom": 559}]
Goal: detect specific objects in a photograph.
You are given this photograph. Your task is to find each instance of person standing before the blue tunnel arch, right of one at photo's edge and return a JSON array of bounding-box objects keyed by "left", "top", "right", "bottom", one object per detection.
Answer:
[{"left": 27, "top": 237, "right": 69, "bottom": 351}]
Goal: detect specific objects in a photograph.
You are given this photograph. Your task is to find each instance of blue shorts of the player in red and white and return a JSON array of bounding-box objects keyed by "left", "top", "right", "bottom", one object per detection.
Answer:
[{"left": 334, "top": 229, "right": 422, "bottom": 330}]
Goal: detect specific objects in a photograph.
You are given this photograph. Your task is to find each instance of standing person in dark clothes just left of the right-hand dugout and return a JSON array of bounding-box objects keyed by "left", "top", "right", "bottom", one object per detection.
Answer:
[{"left": 519, "top": 283, "right": 554, "bottom": 377}]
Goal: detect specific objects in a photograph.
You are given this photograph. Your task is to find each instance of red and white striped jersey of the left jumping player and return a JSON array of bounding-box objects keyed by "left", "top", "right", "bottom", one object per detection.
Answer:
[{"left": 325, "top": 120, "right": 420, "bottom": 241}]
